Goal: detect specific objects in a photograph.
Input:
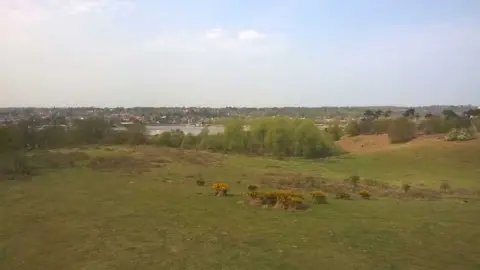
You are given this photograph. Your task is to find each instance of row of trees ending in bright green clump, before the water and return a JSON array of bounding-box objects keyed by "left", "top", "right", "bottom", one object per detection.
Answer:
[{"left": 0, "top": 117, "right": 336, "bottom": 158}]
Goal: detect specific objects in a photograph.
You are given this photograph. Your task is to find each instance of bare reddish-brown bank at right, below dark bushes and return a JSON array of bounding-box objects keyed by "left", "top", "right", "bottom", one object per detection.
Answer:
[{"left": 337, "top": 134, "right": 480, "bottom": 153}]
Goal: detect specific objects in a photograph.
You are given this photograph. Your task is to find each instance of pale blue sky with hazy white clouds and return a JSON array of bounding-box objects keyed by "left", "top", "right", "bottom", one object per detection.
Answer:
[{"left": 0, "top": 0, "right": 480, "bottom": 107}]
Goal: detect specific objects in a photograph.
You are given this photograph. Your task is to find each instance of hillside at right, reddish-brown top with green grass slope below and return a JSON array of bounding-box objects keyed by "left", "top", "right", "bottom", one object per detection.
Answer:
[{"left": 322, "top": 135, "right": 480, "bottom": 190}]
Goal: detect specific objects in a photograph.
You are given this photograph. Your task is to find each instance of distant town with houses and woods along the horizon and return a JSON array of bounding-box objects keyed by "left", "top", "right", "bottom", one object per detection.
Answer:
[{"left": 0, "top": 105, "right": 478, "bottom": 126}]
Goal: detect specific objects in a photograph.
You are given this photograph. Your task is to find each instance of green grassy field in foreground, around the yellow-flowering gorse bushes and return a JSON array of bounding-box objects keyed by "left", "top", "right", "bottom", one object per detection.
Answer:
[{"left": 0, "top": 141, "right": 480, "bottom": 270}]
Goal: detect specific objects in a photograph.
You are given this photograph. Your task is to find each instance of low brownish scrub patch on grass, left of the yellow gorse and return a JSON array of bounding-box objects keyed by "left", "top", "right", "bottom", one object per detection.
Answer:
[{"left": 87, "top": 156, "right": 152, "bottom": 174}]
